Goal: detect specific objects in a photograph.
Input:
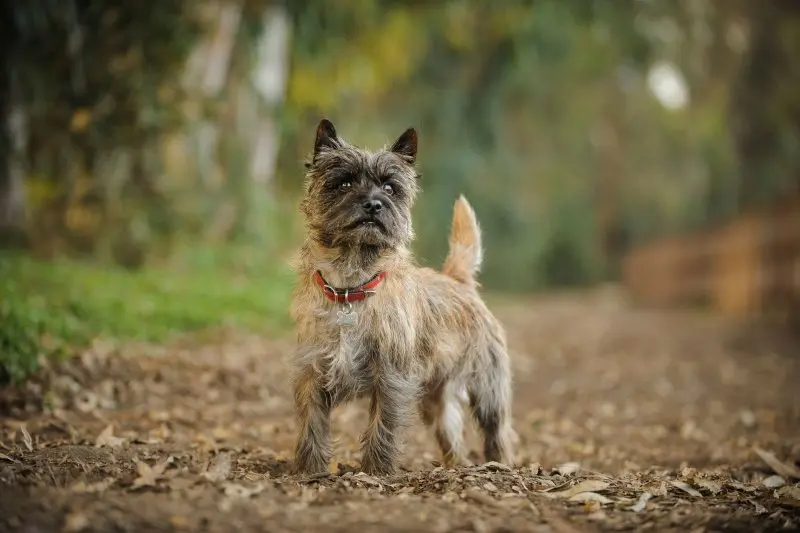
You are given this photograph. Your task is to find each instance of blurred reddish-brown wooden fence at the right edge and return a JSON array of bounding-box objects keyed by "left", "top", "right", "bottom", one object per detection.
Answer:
[{"left": 622, "top": 193, "right": 800, "bottom": 324}]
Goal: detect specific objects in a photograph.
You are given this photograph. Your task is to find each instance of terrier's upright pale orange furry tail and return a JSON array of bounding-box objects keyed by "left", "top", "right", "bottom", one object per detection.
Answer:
[{"left": 442, "top": 196, "right": 483, "bottom": 285}]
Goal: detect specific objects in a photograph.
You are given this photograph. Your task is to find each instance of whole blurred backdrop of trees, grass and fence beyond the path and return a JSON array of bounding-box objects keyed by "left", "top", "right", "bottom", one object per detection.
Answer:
[{"left": 0, "top": 0, "right": 800, "bottom": 378}]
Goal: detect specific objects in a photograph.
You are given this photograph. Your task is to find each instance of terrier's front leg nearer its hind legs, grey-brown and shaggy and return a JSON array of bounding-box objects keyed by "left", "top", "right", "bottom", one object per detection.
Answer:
[{"left": 361, "top": 370, "right": 416, "bottom": 474}]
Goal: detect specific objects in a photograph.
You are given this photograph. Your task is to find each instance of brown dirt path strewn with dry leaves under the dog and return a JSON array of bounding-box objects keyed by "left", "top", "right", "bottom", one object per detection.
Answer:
[{"left": 0, "top": 288, "right": 800, "bottom": 533}]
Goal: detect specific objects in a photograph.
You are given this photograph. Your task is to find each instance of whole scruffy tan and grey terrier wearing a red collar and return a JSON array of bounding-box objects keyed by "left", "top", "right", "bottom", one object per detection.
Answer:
[{"left": 291, "top": 120, "right": 513, "bottom": 474}]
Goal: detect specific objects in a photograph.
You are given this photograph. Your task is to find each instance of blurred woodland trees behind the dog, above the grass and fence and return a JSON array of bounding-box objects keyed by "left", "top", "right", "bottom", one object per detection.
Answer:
[{"left": 0, "top": 0, "right": 798, "bottom": 290}]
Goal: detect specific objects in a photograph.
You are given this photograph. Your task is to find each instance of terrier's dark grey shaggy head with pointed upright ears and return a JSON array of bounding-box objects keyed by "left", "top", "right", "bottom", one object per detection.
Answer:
[{"left": 301, "top": 120, "right": 418, "bottom": 249}]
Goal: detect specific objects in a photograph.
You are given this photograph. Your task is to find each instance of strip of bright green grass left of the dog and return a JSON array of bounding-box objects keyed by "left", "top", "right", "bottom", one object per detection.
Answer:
[{"left": 0, "top": 247, "right": 293, "bottom": 382}]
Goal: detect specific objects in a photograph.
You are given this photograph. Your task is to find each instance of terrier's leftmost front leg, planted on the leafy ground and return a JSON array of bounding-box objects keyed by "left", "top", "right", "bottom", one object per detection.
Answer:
[{"left": 294, "top": 366, "right": 333, "bottom": 473}]
